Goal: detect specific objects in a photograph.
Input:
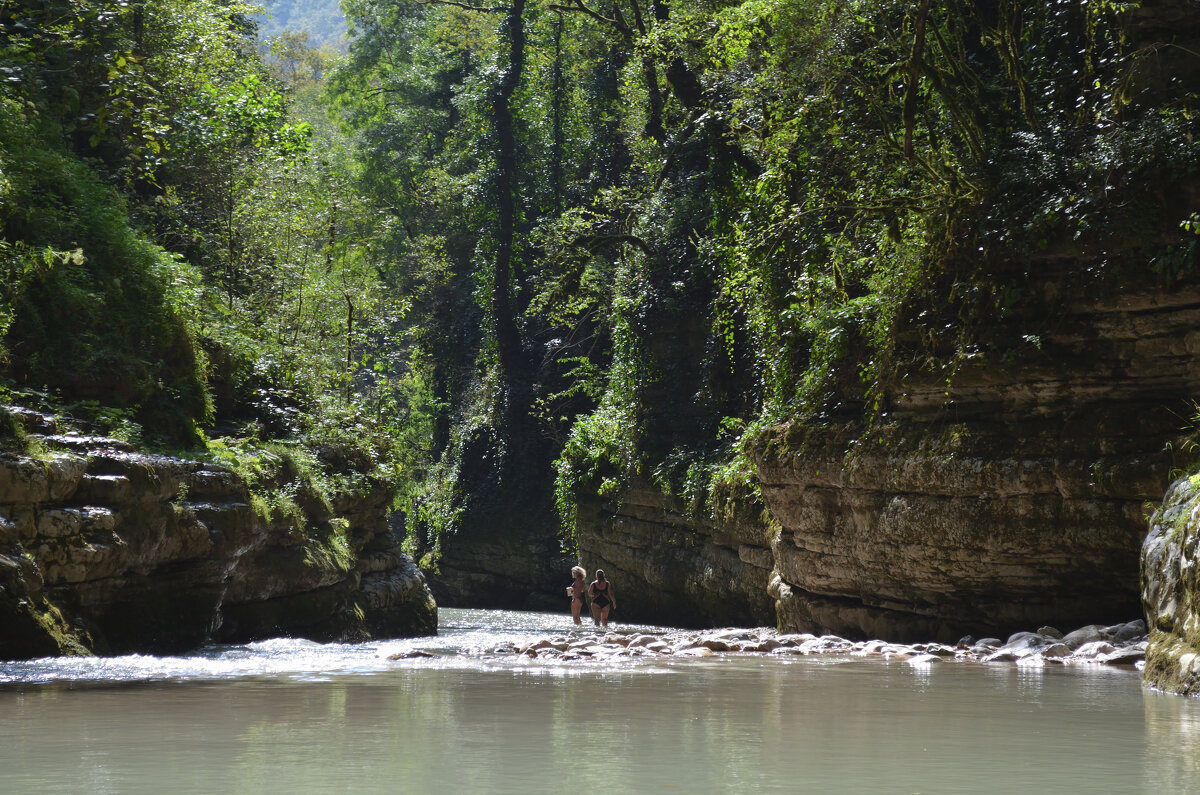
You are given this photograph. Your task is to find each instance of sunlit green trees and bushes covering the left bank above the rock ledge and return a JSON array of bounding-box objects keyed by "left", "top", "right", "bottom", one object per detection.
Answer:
[{"left": 0, "top": 0, "right": 430, "bottom": 525}]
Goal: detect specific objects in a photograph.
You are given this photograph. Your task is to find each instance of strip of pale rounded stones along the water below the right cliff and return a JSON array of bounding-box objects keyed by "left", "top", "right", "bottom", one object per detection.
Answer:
[{"left": 389, "top": 618, "right": 1147, "bottom": 668}]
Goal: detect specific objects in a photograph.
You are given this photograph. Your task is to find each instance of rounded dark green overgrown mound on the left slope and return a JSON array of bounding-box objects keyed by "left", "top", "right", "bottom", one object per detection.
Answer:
[{"left": 0, "top": 94, "right": 210, "bottom": 440}]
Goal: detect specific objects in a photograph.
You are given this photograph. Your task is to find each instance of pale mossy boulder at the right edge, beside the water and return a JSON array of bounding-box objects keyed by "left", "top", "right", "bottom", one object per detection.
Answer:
[{"left": 1141, "top": 478, "right": 1200, "bottom": 695}]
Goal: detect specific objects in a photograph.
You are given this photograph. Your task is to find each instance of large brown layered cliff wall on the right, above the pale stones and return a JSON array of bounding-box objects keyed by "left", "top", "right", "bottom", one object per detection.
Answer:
[{"left": 756, "top": 288, "right": 1200, "bottom": 640}]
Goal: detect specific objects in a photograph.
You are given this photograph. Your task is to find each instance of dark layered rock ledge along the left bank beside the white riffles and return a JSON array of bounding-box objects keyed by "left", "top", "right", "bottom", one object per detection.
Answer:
[{"left": 0, "top": 414, "right": 437, "bottom": 659}]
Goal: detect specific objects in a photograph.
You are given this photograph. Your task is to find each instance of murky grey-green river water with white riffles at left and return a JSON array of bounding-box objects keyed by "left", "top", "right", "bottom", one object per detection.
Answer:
[{"left": 0, "top": 609, "right": 1200, "bottom": 794}]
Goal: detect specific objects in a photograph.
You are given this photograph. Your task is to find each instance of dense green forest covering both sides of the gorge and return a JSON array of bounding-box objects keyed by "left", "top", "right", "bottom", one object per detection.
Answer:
[{"left": 0, "top": 0, "right": 1200, "bottom": 605}]
